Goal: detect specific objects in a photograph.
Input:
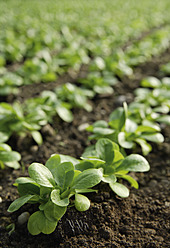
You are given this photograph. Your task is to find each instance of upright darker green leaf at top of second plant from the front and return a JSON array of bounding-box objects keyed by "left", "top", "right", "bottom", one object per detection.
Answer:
[{"left": 95, "top": 139, "right": 114, "bottom": 165}]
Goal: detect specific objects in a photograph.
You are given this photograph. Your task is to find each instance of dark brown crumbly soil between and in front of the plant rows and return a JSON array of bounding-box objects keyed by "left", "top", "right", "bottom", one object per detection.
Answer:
[{"left": 0, "top": 50, "right": 170, "bottom": 248}]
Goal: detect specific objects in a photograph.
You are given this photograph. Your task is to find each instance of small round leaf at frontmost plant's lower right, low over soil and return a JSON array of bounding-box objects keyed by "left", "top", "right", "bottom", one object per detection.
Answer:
[{"left": 74, "top": 194, "right": 90, "bottom": 211}]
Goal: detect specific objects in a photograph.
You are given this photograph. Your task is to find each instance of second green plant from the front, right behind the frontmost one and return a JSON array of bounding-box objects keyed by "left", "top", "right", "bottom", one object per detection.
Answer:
[{"left": 75, "top": 138, "right": 150, "bottom": 197}]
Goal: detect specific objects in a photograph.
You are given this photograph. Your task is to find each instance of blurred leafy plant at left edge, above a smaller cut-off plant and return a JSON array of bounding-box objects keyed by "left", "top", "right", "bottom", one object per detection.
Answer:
[{"left": 0, "top": 102, "right": 47, "bottom": 145}]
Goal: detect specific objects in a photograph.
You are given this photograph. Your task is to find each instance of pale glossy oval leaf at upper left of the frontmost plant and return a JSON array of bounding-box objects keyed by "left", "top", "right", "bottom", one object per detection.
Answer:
[{"left": 28, "top": 163, "right": 55, "bottom": 188}]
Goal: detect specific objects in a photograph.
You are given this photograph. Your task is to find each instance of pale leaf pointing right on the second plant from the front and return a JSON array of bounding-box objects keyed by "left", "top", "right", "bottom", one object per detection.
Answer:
[{"left": 116, "top": 154, "right": 150, "bottom": 172}]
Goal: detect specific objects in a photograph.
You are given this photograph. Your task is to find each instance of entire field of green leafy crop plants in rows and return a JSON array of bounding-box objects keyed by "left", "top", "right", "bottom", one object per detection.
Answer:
[{"left": 0, "top": 0, "right": 170, "bottom": 240}]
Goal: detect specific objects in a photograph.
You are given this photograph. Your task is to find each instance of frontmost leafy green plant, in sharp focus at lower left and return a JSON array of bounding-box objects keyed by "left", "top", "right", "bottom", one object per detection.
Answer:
[{"left": 8, "top": 154, "right": 102, "bottom": 235}]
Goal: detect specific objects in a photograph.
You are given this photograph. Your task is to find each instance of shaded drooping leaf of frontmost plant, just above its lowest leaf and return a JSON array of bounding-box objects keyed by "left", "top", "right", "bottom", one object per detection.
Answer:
[{"left": 44, "top": 201, "right": 67, "bottom": 221}]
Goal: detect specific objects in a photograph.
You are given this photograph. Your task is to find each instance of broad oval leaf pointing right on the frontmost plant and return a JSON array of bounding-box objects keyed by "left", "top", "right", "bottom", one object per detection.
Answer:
[{"left": 72, "top": 169, "right": 103, "bottom": 189}]
